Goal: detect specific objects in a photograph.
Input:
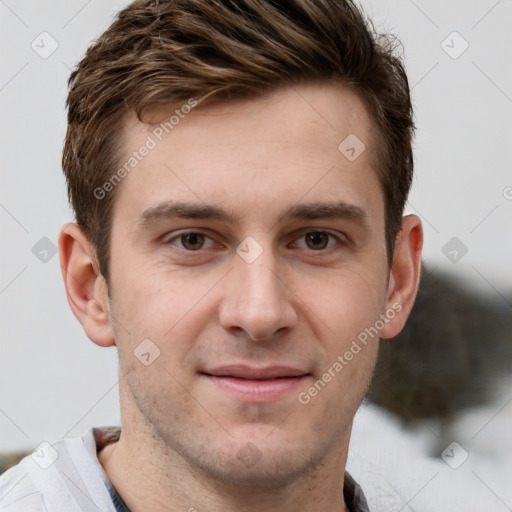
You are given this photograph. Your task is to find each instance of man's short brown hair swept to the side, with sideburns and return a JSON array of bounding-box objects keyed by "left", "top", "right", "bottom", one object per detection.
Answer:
[{"left": 62, "top": 0, "right": 414, "bottom": 281}]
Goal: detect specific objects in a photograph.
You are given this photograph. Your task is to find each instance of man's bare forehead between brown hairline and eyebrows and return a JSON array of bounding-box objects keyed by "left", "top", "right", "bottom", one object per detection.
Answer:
[{"left": 114, "top": 83, "right": 382, "bottom": 232}]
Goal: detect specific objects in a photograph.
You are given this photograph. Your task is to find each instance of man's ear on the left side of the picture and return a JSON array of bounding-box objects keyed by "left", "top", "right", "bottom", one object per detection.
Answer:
[{"left": 59, "top": 223, "right": 115, "bottom": 347}]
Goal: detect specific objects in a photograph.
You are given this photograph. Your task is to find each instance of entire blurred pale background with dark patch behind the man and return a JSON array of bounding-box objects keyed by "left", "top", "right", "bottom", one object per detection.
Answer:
[{"left": 0, "top": 0, "right": 512, "bottom": 512}]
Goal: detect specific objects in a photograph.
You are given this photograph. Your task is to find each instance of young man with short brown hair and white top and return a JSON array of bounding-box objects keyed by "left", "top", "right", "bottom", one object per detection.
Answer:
[{"left": 0, "top": 0, "right": 422, "bottom": 512}]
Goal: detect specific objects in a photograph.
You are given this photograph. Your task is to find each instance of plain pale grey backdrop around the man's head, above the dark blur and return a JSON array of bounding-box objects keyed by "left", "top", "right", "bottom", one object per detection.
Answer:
[{"left": 0, "top": 0, "right": 512, "bottom": 510}]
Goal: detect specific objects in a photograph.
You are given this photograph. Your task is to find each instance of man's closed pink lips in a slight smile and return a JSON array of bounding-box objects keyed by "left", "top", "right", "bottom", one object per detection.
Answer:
[{"left": 199, "top": 365, "right": 311, "bottom": 402}]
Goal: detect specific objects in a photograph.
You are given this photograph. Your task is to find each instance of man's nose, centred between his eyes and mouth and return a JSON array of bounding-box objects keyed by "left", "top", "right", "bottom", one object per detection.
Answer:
[{"left": 219, "top": 249, "right": 297, "bottom": 341}]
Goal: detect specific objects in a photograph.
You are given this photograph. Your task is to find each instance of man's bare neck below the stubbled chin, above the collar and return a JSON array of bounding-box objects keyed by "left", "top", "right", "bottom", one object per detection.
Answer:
[{"left": 98, "top": 428, "right": 350, "bottom": 512}]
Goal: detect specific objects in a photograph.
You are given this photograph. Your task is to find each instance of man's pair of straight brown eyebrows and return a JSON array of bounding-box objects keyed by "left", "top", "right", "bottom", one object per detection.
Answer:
[{"left": 136, "top": 201, "right": 368, "bottom": 230}]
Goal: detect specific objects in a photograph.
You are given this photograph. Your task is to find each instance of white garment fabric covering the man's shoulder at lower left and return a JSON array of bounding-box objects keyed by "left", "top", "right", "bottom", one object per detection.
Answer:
[{"left": 0, "top": 429, "right": 115, "bottom": 512}]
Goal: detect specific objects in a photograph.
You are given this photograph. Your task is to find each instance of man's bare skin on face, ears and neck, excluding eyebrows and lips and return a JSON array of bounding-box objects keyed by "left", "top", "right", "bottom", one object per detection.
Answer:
[{"left": 59, "top": 83, "right": 422, "bottom": 512}]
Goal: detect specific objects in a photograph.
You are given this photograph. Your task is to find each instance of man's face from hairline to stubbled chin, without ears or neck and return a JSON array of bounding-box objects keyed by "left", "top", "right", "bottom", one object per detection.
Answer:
[{"left": 109, "top": 84, "right": 399, "bottom": 486}]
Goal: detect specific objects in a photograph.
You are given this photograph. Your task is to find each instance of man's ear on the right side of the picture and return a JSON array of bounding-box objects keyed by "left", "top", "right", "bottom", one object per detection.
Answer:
[{"left": 380, "top": 215, "right": 423, "bottom": 338}]
